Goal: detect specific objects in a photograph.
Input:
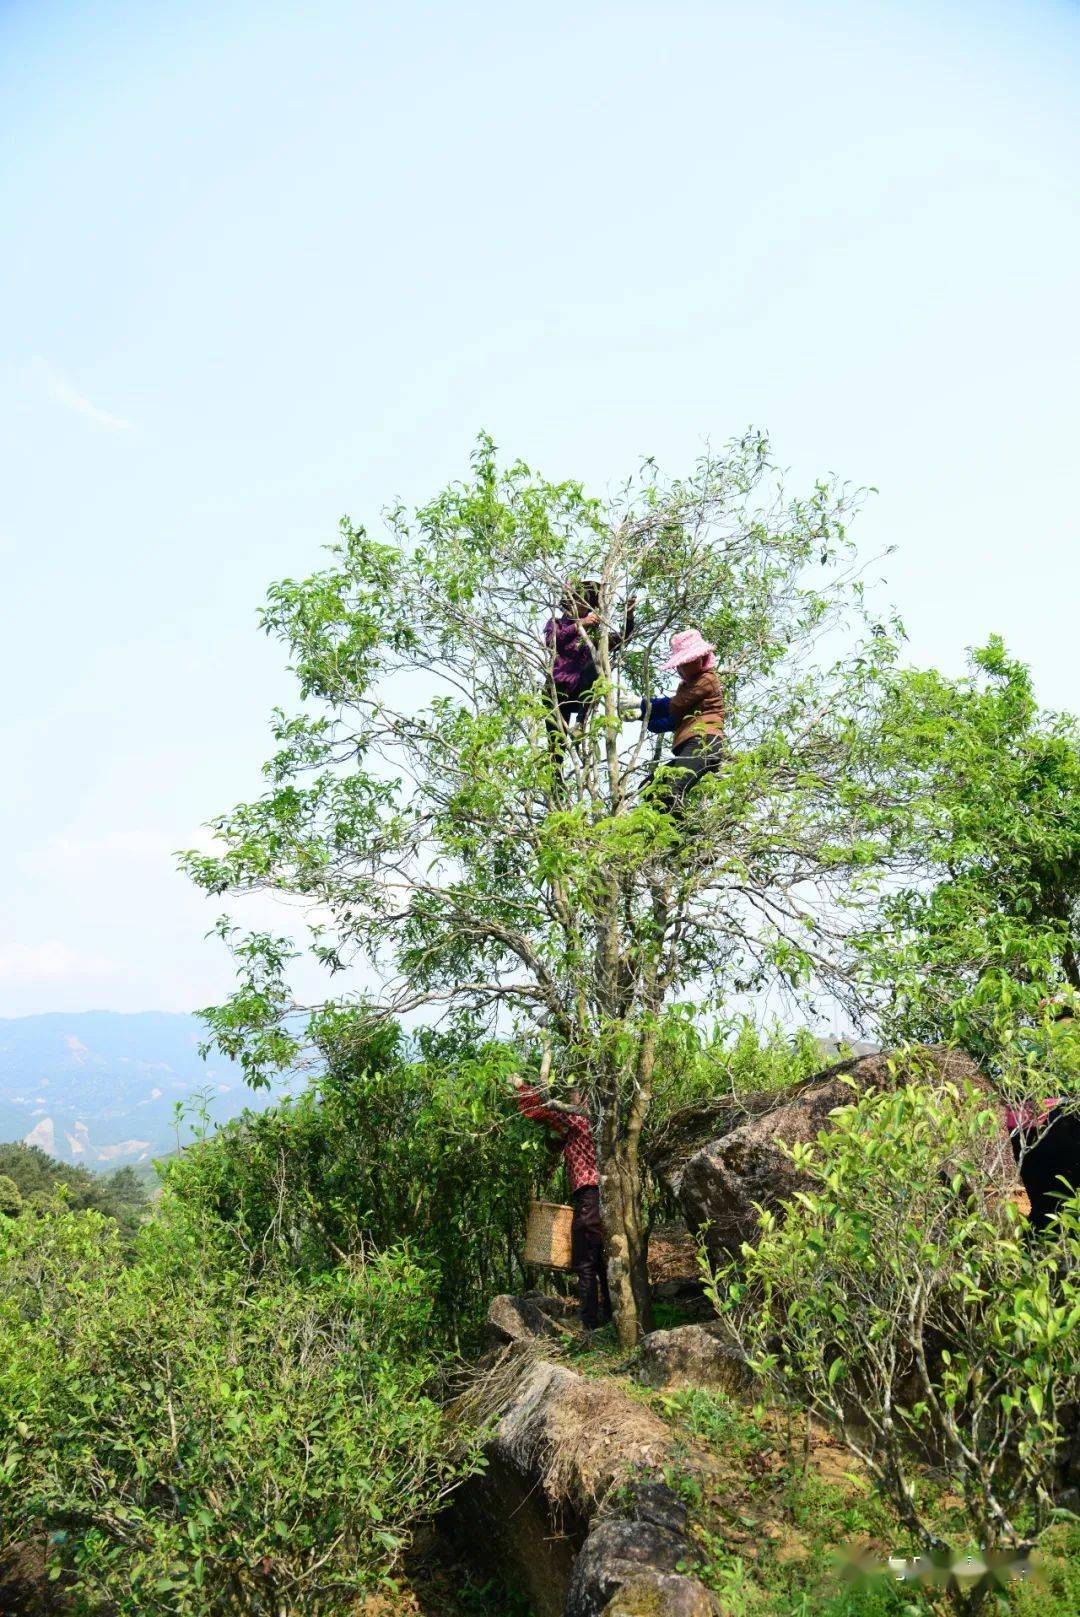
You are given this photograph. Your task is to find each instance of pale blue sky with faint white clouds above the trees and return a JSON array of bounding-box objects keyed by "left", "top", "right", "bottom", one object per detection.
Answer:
[{"left": 0, "top": 0, "right": 1080, "bottom": 1014}]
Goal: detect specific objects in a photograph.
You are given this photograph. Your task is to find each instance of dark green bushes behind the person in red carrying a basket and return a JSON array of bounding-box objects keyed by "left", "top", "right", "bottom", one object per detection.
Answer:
[{"left": 168, "top": 1035, "right": 553, "bottom": 1344}]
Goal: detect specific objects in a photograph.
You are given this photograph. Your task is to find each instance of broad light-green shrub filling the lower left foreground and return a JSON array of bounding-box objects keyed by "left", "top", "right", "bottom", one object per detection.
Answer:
[{"left": 0, "top": 1197, "right": 467, "bottom": 1617}]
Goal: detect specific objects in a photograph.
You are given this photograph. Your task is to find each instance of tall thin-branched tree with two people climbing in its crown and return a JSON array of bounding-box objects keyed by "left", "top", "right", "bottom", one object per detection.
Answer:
[{"left": 188, "top": 435, "right": 894, "bottom": 1342}]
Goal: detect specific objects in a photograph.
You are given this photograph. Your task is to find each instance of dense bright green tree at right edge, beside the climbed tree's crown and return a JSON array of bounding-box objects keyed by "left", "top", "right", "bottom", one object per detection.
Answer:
[{"left": 859, "top": 639, "right": 1080, "bottom": 1059}]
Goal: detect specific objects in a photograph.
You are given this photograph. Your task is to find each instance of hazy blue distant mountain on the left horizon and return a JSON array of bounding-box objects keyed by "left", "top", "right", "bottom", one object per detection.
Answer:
[{"left": 0, "top": 1011, "right": 286, "bottom": 1171}]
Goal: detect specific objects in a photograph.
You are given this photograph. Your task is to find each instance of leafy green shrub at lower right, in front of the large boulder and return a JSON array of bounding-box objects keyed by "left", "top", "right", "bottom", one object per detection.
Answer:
[{"left": 711, "top": 1087, "right": 1080, "bottom": 1609}]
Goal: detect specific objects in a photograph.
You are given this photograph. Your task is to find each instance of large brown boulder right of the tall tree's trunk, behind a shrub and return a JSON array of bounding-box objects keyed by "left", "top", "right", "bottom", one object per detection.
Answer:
[{"left": 677, "top": 1045, "right": 1010, "bottom": 1258}]
